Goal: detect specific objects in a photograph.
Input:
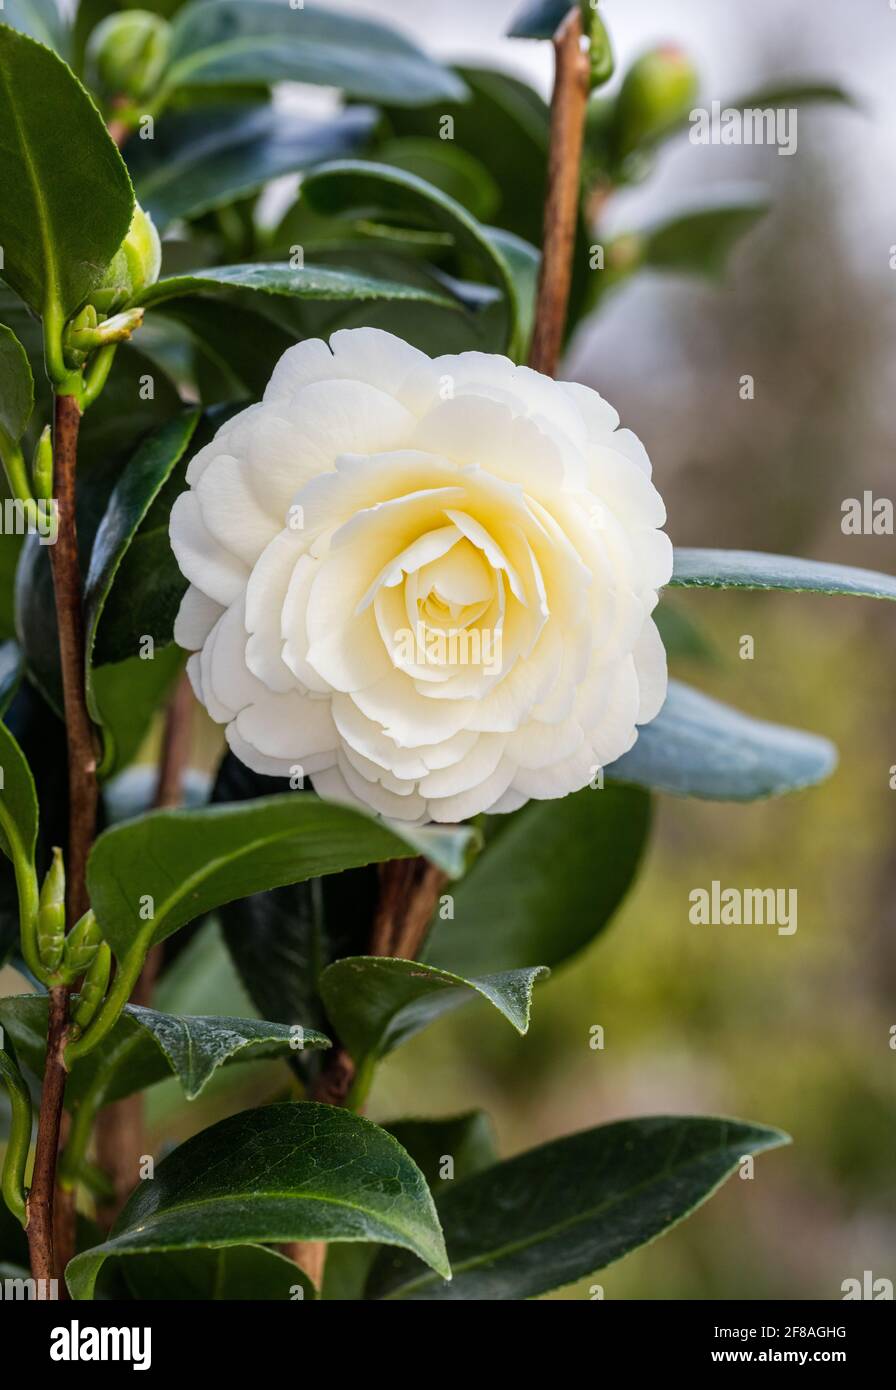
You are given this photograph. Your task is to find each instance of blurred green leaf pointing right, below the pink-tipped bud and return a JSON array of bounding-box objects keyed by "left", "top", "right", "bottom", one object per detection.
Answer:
[{"left": 640, "top": 189, "right": 771, "bottom": 279}]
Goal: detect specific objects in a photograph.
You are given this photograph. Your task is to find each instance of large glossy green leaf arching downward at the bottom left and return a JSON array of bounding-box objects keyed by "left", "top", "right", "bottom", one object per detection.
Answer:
[{"left": 65, "top": 1102, "right": 450, "bottom": 1298}]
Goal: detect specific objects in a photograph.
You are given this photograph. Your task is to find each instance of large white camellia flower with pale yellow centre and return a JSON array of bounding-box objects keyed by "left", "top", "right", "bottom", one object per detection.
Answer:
[{"left": 171, "top": 328, "right": 672, "bottom": 821}]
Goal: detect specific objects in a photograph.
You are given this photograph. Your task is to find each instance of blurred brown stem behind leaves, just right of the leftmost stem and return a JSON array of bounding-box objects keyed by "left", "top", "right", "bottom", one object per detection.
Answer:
[{"left": 94, "top": 674, "right": 193, "bottom": 1229}]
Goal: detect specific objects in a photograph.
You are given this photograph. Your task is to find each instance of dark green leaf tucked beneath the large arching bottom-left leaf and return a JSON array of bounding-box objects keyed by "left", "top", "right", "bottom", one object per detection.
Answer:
[{"left": 122, "top": 1245, "right": 317, "bottom": 1302}]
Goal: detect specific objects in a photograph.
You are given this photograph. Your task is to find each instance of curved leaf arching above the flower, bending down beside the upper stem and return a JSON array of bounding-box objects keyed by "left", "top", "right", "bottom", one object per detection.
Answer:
[{"left": 301, "top": 160, "right": 522, "bottom": 358}]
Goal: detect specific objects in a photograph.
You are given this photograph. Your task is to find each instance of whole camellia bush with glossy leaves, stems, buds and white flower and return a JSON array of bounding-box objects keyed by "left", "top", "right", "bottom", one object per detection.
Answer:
[{"left": 0, "top": 0, "right": 896, "bottom": 1300}]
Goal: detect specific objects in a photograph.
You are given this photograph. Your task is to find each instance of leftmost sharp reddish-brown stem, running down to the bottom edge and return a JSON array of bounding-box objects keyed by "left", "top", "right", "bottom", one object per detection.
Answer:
[{"left": 26, "top": 396, "right": 97, "bottom": 1297}]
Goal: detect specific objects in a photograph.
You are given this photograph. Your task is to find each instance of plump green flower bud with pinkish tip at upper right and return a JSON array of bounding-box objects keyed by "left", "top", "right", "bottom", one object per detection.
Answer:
[{"left": 615, "top": 43, "right": 697, "bottom": 158}]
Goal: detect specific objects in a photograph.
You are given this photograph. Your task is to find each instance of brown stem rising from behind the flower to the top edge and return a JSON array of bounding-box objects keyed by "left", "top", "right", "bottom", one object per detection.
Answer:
[{"left": 529, "top": 4, "right": 590, "bottom": 377}]
